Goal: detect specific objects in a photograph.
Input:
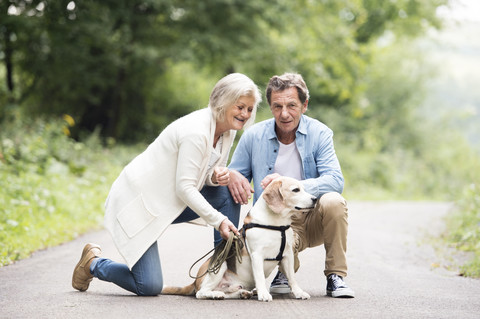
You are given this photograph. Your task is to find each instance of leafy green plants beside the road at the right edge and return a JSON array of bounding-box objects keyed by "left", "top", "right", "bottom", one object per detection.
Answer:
[{"left": 445, "top": 183, "right": 480, "bottom": 278}]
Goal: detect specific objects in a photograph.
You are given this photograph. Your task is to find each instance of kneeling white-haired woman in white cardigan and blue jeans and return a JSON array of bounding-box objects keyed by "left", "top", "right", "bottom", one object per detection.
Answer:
[{"left": 72, "top": 73, "right": 261, "bottom": 296}]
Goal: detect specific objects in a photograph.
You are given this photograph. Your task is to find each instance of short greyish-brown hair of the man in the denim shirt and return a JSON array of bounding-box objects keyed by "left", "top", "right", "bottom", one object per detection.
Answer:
[{"left": 265, "top": 73, "right": 310, "bottom": 105}]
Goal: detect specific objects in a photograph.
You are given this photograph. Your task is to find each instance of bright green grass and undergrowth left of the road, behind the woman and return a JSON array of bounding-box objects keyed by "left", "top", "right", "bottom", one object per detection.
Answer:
[{"left": 0, "top": 115, "right": 137, "bottom": 266}]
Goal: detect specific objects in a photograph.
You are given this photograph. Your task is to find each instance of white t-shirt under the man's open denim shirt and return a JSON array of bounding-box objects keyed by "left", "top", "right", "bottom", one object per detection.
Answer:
[{"left": 273, "top": 141, "right": 303, "bottom": 180}]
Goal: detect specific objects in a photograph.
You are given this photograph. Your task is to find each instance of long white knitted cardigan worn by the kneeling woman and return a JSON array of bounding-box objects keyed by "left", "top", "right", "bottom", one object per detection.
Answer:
[{"left": 105, "top": 108, "right": 236, "bottom": 269}]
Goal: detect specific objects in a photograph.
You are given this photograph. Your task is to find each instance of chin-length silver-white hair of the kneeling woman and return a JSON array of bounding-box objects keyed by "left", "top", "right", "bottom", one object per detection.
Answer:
[{"left": 208, "top": 73, "right": 262, "bottom": 127}]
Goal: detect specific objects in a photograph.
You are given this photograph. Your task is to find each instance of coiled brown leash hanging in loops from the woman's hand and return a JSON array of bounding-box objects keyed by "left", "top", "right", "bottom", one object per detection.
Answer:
[{"left": 188, "top": 231, "right": 243, "bottom": 279}]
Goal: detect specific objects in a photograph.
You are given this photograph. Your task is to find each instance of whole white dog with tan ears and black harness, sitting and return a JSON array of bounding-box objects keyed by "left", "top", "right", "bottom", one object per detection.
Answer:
[{"left": 162, "top": 177, "right": 316, "bottom": 301}]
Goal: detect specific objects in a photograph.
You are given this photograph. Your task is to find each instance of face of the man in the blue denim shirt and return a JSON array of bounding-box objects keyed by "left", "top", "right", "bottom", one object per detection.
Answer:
[{"left": 270, "top": 87, "right": 308, "bottom": 135}]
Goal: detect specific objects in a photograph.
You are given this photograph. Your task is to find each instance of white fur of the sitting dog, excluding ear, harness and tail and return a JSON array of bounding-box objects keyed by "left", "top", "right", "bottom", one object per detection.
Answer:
[{"left": 196, "top": 177, "right": 314, "bottom": 301}]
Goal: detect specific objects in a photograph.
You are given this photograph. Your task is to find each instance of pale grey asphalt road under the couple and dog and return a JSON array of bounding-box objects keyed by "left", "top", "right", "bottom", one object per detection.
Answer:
[{"left": 0, "top": 202, "right": 480, "bottom": 318}]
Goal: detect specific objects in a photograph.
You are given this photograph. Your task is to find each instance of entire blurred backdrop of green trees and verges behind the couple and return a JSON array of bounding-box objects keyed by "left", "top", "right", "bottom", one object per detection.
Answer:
[{"left": 0, "top": 0, "right": 480, "bottom": 276}]
